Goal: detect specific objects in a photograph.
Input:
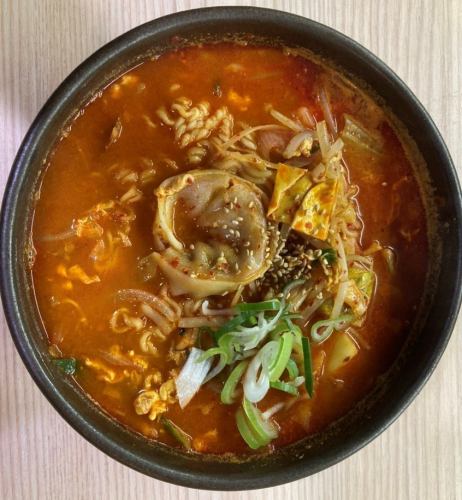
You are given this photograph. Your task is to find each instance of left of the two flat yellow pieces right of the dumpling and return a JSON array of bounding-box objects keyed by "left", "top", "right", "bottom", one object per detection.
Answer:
[{"left": 268, "top": 163, "right": 311, "bottom": 224}]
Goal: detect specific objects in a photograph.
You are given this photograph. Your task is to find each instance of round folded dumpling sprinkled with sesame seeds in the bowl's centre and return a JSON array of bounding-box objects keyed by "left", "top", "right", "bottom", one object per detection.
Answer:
[{"left": 153, "top": 169, "right": 277, "bottom": 298}]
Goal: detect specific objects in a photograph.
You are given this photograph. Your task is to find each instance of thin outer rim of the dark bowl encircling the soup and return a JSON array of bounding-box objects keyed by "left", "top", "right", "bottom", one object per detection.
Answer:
[{"left": 0, "top": 7, "right": 462, "bottom": 490}]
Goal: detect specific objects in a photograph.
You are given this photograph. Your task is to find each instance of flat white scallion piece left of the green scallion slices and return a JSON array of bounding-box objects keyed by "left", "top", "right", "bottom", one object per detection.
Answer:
[{"left": 175, "top": 347, "right": 212, "bottom": 409}]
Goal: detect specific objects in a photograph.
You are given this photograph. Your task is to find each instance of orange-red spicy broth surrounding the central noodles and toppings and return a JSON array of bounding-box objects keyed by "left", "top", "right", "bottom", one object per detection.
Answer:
[{"left": 32, "top": 44, "right": 427, "bottom": 454}]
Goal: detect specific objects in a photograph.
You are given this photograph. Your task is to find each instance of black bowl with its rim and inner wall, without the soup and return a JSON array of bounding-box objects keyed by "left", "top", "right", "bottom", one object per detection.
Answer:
[{"left": 0, "top": 7, "right": 462, "bottom": 490}]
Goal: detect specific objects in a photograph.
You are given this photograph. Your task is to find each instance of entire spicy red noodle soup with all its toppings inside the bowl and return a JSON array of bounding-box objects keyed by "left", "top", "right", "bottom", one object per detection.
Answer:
[{"left": 33, "top": 43, "right": 427, "bottom": 454}]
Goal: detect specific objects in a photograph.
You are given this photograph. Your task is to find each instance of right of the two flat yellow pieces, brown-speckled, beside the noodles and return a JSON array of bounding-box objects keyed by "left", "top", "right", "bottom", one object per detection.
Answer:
[{"left": 292, "top": 179, "right": 338, "bottom": 241}]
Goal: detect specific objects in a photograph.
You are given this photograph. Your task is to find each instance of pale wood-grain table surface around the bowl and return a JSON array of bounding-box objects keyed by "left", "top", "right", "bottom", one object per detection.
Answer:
[{"left": 0, "top": 0, "right": 462, "bottom": 500}]
